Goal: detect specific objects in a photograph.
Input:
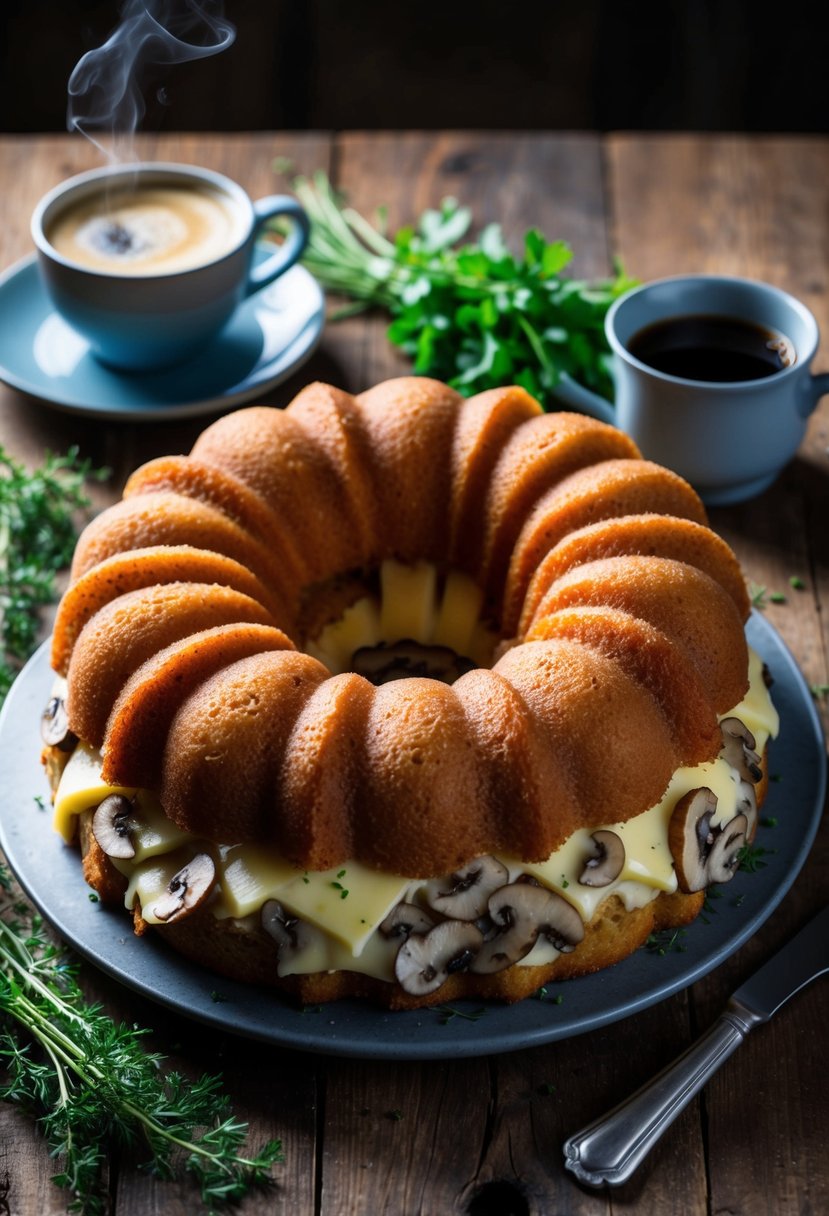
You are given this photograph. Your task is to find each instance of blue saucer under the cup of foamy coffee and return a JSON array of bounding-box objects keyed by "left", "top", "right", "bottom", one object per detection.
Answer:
[{"left": 0, "top": 255, "right": 325, "bottom": 422}]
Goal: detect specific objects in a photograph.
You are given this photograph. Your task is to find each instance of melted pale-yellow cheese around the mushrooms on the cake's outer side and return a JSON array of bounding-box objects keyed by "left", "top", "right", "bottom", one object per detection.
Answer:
[{"left": 55, "top": 651, "right": 779, "bottom": 980}]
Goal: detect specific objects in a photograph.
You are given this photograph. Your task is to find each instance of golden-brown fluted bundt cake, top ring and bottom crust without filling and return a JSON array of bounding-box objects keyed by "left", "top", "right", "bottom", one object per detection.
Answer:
[{"left": 48, "top": 377, "right": 763, "bottom": 1007}]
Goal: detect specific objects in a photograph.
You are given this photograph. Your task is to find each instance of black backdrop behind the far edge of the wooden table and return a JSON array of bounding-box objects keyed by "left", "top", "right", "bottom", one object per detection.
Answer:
[{"left": 0, "top": 0, "right": 829, "bottom": 133}]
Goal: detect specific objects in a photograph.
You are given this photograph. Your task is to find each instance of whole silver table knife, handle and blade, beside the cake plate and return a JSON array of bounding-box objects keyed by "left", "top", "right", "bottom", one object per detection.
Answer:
[{"left": 563, "top": 907, "right": 829, "bottom": 1187}]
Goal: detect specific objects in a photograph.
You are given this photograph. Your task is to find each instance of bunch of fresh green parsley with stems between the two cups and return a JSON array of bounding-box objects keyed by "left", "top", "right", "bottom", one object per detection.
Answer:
[{"left": 286, "top": 173, "right": 636, "bottom": 404}]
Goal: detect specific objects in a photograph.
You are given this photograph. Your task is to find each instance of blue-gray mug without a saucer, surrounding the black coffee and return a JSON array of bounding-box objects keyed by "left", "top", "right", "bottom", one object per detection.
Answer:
[{"left": 556, "top": 275, "right": 829, "bottom": 506}]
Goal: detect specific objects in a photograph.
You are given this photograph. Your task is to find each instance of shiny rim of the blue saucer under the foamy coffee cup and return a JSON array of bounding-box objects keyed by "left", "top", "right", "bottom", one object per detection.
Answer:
[{"left": 0, "top": 253, "right": 326, "bottom": 423}]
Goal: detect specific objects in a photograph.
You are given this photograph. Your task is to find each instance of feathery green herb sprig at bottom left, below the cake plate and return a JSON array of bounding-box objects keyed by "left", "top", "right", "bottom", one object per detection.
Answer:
[{"left": 0, "top": 865, "right": 282, "bottom": 1216}]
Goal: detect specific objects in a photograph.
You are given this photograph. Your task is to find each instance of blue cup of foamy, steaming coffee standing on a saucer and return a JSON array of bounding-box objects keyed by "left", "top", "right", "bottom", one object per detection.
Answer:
[{"left": 32, "top": 163, "right": 310, "bottom": 371}]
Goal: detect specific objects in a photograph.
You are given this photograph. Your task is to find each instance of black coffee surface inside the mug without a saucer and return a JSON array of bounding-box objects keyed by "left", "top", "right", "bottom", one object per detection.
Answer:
[{"left": 627, "top": 315, "right": 795, "bottom": 382}]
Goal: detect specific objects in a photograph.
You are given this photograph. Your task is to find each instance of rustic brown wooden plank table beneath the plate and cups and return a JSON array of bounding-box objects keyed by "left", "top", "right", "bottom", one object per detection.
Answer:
[{"left": 0, "top": 133, "right": 829, "bottom": 1216}]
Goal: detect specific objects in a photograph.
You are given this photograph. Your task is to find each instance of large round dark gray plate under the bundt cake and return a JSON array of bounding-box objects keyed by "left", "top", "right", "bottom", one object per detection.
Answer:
[{"left": 0, "top": 614, "right": 825, "bottom": 1059}]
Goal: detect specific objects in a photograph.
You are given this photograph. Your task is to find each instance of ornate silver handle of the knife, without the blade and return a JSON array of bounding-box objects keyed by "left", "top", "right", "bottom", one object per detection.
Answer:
[{"left": 563, "top": 1000, "right": 765, "bottom": 1187}]
